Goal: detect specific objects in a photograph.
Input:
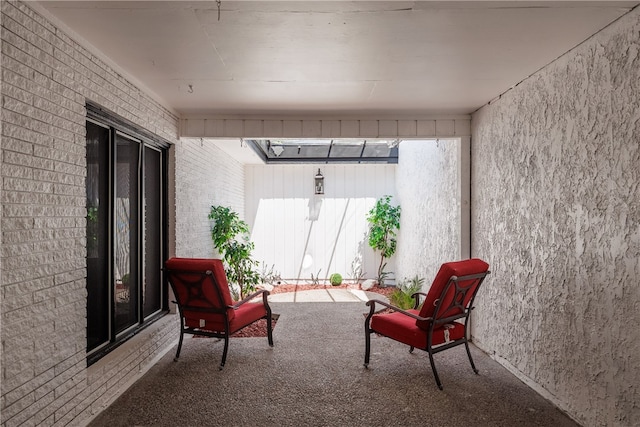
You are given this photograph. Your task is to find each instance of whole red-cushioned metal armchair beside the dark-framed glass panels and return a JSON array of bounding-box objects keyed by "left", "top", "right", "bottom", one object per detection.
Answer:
[{"left": 165, "top": 258, "right": 273, "bottom": 369}]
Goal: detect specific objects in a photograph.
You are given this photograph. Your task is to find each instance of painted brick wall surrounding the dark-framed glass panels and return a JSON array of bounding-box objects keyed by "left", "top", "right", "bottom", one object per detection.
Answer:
[{"left": 0, "top": 1, "right": 192, "bottom": 427}]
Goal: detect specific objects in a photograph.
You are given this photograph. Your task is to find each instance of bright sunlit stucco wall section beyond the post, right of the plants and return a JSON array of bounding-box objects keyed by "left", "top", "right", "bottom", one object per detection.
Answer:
[{"left": 396, "top": 139, "right": 460, "bottom": 288}]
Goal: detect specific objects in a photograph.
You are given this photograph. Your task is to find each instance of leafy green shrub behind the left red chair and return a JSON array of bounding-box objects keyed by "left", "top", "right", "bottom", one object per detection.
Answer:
[{"left": 209, "top": 206, "right": 260, "bottom": 299}]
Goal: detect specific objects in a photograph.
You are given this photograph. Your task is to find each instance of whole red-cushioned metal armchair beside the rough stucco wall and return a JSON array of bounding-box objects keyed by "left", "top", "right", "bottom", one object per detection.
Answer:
[{"left": 364, "top": 258, "right": 490, "bottom": 390}]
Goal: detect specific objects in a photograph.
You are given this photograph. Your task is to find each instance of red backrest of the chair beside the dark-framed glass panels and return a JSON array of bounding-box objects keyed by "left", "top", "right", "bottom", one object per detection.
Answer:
[{"left": 165, "top": 258, "right": 235, "bottom": 330}]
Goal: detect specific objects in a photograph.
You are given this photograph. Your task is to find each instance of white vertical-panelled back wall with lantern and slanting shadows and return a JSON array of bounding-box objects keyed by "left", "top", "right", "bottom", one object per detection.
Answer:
[{"left": 245, "top": 164, "right": 397, "bottom": 283}]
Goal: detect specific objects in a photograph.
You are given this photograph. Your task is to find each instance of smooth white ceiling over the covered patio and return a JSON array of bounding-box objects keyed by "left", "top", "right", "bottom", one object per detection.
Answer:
[{"left": 39, "top": 0, "right": 639, "bottom": 117}]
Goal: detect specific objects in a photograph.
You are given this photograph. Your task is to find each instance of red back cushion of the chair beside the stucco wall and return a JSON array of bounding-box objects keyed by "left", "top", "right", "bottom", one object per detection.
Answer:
[{"left": 416, "top": 258, "right": 489, "bottom": 330}]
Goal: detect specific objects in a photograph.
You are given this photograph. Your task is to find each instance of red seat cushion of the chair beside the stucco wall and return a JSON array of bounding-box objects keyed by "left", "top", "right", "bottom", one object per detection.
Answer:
[{"left": 370, "top": 310, "right": 464, "bottom": 350}]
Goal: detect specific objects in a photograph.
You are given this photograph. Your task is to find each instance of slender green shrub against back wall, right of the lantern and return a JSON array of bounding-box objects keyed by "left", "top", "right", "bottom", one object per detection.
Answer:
[{"left": 367, "top": 196, "right": 400, "bottom": 286}]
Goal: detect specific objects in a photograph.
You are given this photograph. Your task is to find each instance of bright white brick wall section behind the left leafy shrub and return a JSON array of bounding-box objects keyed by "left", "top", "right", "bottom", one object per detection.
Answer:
[{"left": 175, "top": 138, "right": 244, "bottom": 257}]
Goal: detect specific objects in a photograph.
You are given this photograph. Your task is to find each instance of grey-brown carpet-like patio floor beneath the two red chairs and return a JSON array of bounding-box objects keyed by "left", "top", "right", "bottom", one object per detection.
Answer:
[{"left": 91, "top": 303, "right": 577, "bottom": 427}]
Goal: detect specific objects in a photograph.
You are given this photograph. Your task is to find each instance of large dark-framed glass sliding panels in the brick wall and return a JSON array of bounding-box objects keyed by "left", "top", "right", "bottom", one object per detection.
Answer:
[{"left": 86, "top": 106, "right": 168, "bottom": 363}]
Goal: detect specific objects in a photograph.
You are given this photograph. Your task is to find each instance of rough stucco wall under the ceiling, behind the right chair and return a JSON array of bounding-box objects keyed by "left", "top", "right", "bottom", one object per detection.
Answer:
[{"left": 472, "top": 9, "right": 640, "bottom": 426}]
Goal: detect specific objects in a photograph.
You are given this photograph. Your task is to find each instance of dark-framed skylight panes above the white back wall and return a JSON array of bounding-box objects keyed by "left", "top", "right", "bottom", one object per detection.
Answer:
[{"left": 245, "top": 139, "right": 399, "bottom": 163}]
